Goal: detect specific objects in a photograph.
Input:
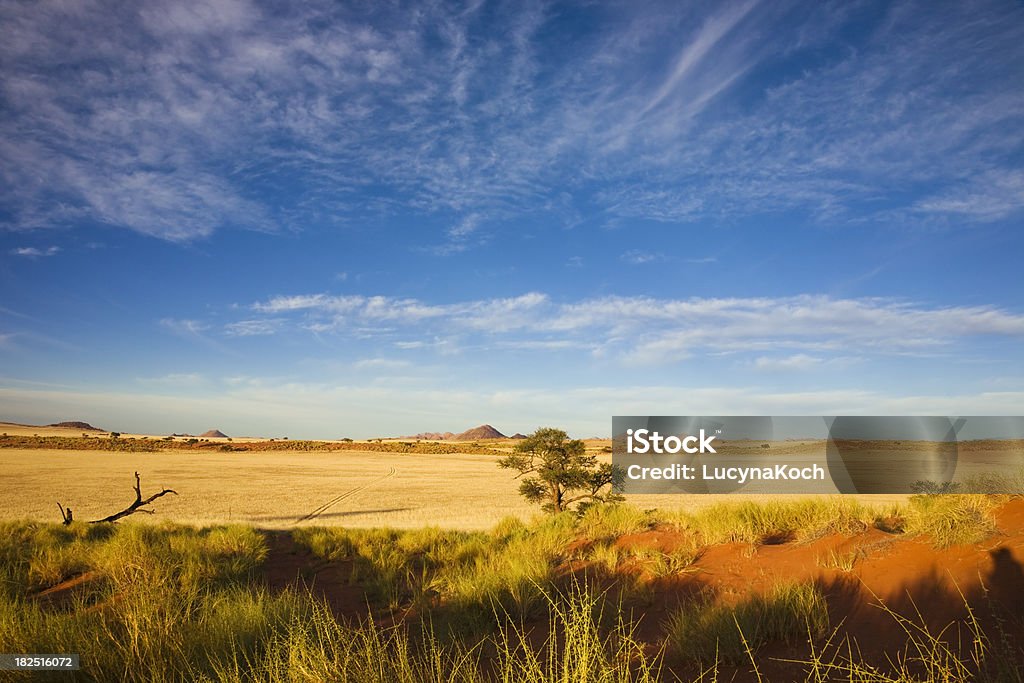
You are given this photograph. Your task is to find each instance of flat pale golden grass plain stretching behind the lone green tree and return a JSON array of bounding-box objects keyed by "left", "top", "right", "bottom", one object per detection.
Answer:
[{"left": 0, "top": 446, "right": 906, "bottom": 530}]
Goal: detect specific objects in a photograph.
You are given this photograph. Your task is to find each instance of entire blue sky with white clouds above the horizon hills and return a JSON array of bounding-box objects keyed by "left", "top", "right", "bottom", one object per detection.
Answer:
[{"left": 0, "top": 0, "right": 1024, "bottom": 438}]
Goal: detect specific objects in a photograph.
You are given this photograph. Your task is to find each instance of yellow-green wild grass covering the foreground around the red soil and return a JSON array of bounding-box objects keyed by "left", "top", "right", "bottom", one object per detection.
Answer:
[{"left": 0, "top": 496, "right": 1020, "bottom": 683}]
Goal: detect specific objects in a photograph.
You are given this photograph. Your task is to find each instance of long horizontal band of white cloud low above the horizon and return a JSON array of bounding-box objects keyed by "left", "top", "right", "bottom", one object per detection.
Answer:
[{"left": 230, "top": 292, "right": 1024, "bottom": 370}]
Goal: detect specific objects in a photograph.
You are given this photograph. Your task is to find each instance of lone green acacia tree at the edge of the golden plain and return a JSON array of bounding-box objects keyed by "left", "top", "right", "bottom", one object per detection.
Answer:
[{"left": 498, "top": 427, "right": 624, "bottom": 513}]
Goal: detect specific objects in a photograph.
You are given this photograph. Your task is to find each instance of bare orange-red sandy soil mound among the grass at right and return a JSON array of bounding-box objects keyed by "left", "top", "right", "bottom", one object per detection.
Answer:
[{"left": 602, "top": 500, "right": 1024, "bottom": 681}]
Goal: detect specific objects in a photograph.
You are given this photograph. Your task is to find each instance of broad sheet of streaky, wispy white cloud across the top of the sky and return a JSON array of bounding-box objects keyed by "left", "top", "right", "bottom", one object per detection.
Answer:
[{"left": 0, "top": 0, "right": 1024, "bottom": 242}]
